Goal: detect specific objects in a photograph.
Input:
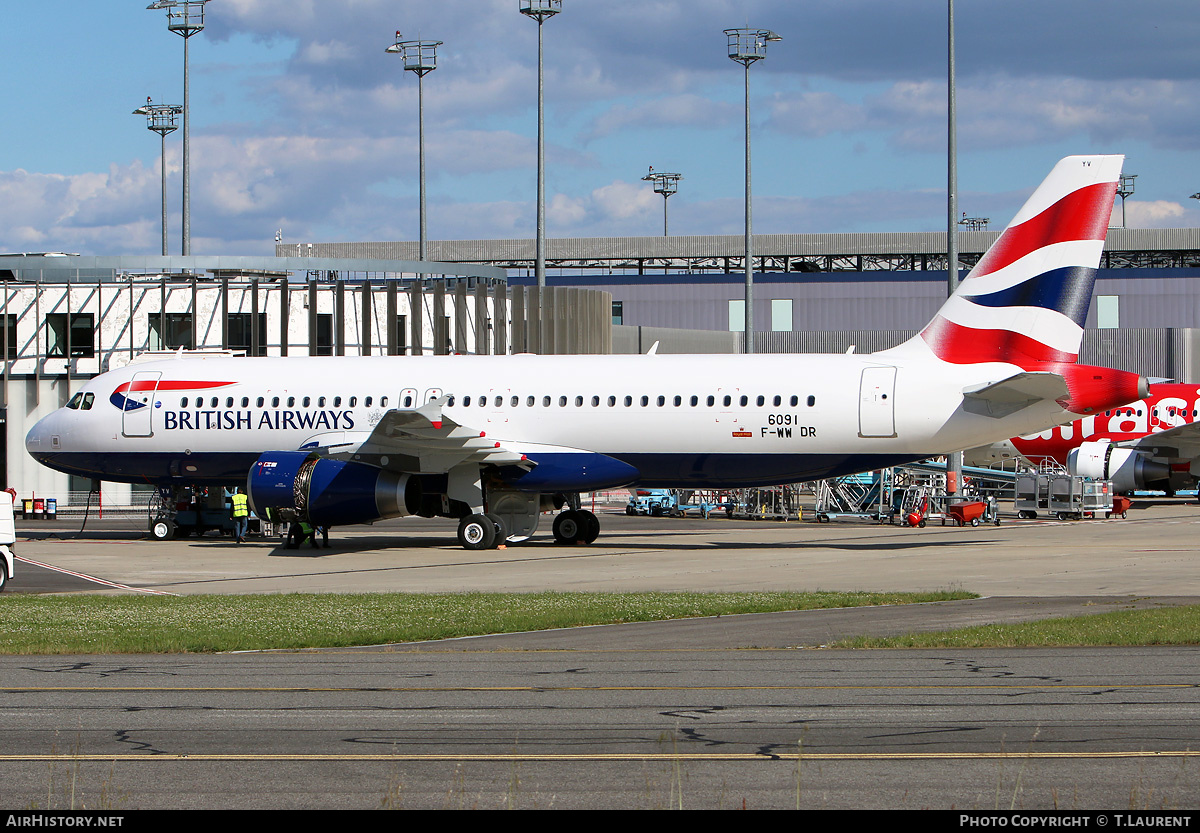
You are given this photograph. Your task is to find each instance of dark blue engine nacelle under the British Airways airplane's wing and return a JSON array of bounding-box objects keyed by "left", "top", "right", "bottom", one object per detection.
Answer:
[{"left": 246, "top": 451, "right": 424, "bottom": 527}]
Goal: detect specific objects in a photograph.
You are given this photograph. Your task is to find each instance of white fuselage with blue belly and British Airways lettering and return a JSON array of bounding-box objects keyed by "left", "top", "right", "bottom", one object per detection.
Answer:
[{"left": 26, "top": 354, "right": 1072, "bottom": 487}]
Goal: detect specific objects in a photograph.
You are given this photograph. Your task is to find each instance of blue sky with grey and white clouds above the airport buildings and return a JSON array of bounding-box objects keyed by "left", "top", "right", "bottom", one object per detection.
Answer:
[{"left": 7, "top": 0, "right": 1200, "bottom": 254}]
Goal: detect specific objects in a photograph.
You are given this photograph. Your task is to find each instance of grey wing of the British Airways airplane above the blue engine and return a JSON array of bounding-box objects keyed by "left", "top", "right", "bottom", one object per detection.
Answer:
[{"left": 328, "top": 396, "right": 535, "bottom": 474}]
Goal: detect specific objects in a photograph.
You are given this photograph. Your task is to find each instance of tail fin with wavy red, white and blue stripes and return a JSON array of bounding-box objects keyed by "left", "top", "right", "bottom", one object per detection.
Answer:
[{"left": 894, "top": 156, "right": 1124, "bottom": 370}]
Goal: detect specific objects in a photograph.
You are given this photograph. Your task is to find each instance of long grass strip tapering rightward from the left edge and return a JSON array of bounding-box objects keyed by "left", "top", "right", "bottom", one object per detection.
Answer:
[{"left": 0, "top": 591, "right": 976, "bottom": 654}]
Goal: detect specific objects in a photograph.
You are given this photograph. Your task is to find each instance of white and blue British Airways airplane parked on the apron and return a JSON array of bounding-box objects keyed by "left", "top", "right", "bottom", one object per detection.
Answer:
[{"left": 26, "top": 156, "right": 1146, "bottom": 549}]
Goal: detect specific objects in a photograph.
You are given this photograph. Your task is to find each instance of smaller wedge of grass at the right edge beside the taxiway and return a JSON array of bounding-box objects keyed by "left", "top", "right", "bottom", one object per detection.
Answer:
[{"left": 833, "top": 605, "right": 1200, "bottom": 648}]
